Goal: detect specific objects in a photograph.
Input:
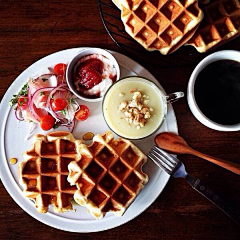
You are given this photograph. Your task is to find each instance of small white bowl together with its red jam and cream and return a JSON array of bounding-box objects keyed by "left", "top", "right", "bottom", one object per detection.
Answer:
[{"left": 66, "top": 48, "right": 120, "bottom": 102}]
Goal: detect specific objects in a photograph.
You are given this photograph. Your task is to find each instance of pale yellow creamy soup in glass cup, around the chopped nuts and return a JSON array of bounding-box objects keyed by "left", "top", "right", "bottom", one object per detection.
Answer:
[{"left": 103, "top": 77, "right": 167, "bottom": 139}]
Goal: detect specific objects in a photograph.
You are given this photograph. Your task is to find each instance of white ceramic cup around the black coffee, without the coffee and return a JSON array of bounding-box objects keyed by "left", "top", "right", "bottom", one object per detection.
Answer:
[{"left": 187, "top": 50, "right": 240, "bottom": 132}]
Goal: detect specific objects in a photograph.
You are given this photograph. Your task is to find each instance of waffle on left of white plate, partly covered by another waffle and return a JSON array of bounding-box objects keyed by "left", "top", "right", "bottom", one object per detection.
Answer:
[{"left": 19, "top": 131, "right": 81, "bottom": 213}]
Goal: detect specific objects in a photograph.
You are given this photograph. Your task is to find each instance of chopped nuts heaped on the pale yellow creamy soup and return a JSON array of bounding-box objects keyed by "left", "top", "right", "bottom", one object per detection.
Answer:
[{"left": 118, "top": 89, "right": 153, "bottom": 129}]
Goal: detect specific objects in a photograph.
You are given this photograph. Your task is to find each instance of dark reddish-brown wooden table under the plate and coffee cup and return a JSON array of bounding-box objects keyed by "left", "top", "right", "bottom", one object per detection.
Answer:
[{"left": 0, "top": 0, "right": 240, "bottom": 239}]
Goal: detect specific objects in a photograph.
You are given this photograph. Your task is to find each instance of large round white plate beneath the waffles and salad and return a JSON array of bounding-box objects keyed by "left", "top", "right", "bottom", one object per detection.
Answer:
[{"left": 0, "top": 48, "right": 177, "bottom": 232}]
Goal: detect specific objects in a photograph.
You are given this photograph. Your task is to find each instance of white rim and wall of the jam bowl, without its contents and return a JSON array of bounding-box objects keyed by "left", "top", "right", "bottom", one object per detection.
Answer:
[{"left": 66, "top": 48, "right": 120, "bottom": 102}]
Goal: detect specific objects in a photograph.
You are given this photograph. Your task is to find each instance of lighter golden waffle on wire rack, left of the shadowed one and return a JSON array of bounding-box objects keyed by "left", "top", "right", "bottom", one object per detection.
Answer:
[{"left": 113, "top": 0, "right": 203, "bottom": 54}]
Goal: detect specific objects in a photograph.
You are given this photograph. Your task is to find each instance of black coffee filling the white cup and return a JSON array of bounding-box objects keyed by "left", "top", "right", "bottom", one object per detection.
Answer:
[{"left": 194, "top": 59, "right": 240, "bottom": 125}]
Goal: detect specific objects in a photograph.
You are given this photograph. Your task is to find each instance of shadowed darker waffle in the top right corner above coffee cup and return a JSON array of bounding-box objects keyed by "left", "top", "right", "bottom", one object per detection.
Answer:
[{"left": 187, "top": 0, "right": 240, "bottom": 52}]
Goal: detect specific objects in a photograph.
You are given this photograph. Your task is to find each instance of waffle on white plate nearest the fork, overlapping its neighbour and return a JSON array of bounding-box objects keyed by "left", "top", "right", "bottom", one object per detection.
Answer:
[{"left": 68, "top": 132, "right": 148, "bottom": 219}]
